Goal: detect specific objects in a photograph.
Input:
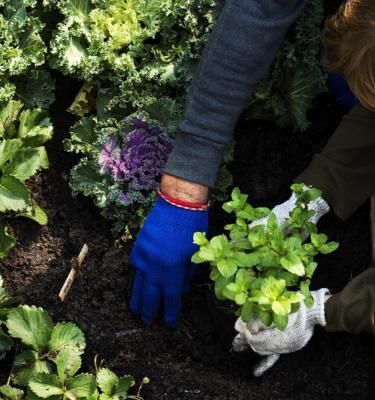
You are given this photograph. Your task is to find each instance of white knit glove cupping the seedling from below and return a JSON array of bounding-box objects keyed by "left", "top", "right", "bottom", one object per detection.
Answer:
[{"left": 232, "top": 289, "right": 329, "bottom": 376}]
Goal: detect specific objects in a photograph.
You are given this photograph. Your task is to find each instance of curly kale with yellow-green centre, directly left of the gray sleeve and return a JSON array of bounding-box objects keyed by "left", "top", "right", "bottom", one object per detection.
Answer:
[{"left": 50, "top": 0, "right": 215, "bottom": 125}]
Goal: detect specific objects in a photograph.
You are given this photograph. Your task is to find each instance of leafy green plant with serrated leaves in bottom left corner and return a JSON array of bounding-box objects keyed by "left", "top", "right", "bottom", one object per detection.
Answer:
[{"left": 0, "top": 277, "right": 149, "bottom": 400}]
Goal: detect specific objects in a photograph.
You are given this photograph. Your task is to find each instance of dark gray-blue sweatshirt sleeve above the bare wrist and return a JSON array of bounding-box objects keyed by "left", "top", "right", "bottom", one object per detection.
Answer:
[{"left": 164, "top": 0, "right": 307, "bottom": 187}]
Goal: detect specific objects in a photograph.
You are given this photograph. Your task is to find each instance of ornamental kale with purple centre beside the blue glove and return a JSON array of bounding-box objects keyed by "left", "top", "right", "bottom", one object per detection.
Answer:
[{"left": 65, "top": 114, "right": 172, "bottom": 238}]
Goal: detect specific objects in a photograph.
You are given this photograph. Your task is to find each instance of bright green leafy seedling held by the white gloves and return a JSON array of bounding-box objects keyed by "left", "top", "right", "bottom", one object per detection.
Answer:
[{"left": 192, "top": 184, "right": 338, "bottom": 330}]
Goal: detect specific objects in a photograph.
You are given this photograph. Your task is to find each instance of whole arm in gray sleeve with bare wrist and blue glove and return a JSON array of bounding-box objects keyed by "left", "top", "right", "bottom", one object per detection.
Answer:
[{"left": 131, "top": 0, "right": 306, "bottom": 325}]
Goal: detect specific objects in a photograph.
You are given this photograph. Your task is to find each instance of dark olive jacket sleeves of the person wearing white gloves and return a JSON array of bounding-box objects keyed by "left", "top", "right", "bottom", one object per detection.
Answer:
[{"left": 295, "top": 105, "right": 375, "bottom": 335}]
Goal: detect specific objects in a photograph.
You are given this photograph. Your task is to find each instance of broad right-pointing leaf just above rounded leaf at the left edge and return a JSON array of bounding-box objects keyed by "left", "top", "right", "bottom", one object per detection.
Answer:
[{"left": 3, "top": 146, "right": 49, "bottom": 182}]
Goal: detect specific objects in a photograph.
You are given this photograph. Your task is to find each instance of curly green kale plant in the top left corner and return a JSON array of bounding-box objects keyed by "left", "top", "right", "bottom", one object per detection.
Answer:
[{"left": 0, "top": 0, "right": 54, "bottom": 108}]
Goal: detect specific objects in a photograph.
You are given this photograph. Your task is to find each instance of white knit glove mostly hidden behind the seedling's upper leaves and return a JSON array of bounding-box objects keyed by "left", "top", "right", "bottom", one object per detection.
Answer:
[{"left": 250, "top": 186, "right": 329, "bottom": 227}]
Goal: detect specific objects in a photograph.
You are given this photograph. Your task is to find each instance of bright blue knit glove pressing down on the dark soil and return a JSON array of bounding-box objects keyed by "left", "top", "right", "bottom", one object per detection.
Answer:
[{"left": 130, "top": 198, "right": 208, "bottom": 326}]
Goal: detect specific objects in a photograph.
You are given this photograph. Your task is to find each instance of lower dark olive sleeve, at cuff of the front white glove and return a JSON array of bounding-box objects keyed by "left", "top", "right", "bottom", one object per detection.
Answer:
[{"left": 325, "top": 267, "right": 375, "bottom": 335}]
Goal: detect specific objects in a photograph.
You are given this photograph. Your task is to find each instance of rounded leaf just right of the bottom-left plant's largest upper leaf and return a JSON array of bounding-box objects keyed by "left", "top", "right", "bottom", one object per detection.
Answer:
[{"left": 49, "top": 322, "right": 86, "bottom": 353}]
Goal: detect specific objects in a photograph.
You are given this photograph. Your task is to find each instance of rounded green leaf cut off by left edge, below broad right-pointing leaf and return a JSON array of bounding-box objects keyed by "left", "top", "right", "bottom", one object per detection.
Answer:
[{"left": 0, "top": 176, "right": 30, "bottom": 212}]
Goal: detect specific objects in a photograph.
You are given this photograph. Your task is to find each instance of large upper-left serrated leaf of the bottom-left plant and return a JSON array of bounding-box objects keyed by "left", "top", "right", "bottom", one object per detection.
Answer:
[{"left": 7, "top": 305, "right": 53, "bottom": 351}]
